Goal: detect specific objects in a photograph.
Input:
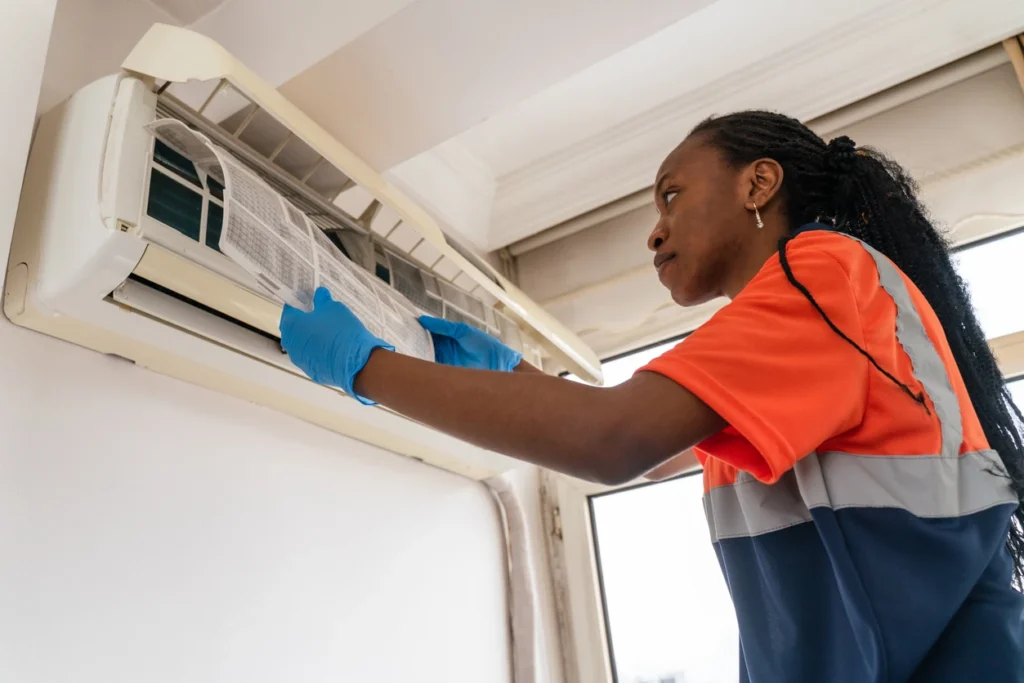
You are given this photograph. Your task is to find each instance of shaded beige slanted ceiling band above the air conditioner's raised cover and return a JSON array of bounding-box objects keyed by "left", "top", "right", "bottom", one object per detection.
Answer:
[{"left": 283, "top": 0, "right": 711, "bottom": 170}]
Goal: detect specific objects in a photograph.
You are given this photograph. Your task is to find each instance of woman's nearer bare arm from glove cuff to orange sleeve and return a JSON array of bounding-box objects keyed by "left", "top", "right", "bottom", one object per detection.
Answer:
[{"left": 354, "top": 348, "right": 725, "bottom": 484}]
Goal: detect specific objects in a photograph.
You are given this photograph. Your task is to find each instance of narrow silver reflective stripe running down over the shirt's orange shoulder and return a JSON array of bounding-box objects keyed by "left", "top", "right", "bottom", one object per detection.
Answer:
[{"left": 844, "top": 236, "right": 964, "bottom": 458}]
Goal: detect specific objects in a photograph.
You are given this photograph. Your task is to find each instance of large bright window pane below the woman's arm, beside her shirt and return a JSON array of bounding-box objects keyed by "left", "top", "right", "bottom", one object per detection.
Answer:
[{"left": 591, "top": 473, "right": 739, "bottom": 683}]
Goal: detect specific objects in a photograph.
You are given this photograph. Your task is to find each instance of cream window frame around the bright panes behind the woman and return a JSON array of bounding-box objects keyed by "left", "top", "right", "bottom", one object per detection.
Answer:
[{"left": 541, "top": 223, "right": 1024, "bottom": 683}]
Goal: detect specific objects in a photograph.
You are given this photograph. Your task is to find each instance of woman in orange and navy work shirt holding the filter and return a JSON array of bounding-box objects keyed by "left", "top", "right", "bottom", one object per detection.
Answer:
[{"left": 282, "top": 112, "right": 1024, "bottom": 683}]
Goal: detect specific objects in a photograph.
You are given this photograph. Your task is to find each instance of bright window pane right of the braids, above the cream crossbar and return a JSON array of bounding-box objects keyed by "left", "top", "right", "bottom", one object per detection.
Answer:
[{"left": 956, "top": 228, "right": 1024, "bottom": 339}]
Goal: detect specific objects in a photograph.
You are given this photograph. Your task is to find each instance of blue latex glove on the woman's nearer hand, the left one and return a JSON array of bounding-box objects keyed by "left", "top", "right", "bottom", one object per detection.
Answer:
[{"left": 281, "top": 287, "right": 394, "bottom": 405}]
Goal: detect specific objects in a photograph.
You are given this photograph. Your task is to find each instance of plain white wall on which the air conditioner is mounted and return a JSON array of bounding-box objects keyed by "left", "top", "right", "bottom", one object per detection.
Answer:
[{"left": 0, "top": 0, "right": 509, "bottom": 683}]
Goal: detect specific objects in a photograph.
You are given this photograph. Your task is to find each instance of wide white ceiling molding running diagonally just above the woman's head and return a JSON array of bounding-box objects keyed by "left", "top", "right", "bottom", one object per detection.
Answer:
[{"left": 488, "top": 0, "right": 1024, "bottom": 249}]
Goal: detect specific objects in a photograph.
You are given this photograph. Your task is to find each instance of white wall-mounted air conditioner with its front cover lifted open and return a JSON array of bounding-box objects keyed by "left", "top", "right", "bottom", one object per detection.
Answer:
[{"left": 4, "top": 25, "right": 600, "bottom": 478}]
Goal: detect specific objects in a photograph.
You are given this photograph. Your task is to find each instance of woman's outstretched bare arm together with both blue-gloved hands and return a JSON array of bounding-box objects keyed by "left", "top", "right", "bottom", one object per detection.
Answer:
[{"left": 279, "top": 288, "right": 725, "bottom": 483}]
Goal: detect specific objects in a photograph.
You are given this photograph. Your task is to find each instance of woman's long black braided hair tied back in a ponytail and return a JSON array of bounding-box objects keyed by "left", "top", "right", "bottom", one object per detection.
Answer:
[{"left": 691, "top": 111, "right": 1024, "bottom": 588}]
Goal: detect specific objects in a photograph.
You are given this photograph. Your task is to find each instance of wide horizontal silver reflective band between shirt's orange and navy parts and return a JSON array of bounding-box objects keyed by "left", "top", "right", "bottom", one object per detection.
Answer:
[{"left": 705, "top": 451, "right": 1017, "bottom": 542}]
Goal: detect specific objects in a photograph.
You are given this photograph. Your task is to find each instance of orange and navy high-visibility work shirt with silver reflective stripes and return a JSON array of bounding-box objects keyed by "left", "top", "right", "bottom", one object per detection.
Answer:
[{"left": 640, "top": 225, "right": 1024, "bottom": 683}]
